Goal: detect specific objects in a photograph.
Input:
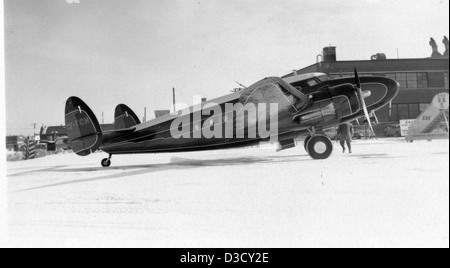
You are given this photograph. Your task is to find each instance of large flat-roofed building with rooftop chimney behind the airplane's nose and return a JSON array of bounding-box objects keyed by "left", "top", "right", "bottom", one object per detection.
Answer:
[{"left": 283, "top": 47, "right": 449, "bottom": 123}]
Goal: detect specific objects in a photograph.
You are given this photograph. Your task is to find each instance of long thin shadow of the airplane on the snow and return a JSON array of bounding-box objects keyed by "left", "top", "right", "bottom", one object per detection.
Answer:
[{"left": 13, "top": 156, "right": 309, "bottom": 193}]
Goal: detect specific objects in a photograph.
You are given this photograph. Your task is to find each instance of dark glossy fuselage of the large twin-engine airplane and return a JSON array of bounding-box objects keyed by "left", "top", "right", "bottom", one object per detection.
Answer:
[{"left": 100, "top": 77, "right": 398, "bottom": 154}]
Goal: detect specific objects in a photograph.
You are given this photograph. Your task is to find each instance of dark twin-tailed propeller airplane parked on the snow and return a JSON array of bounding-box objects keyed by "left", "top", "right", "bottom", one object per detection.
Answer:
[{"left": 65, "top": 69, "right": 399, "bottom": 167}]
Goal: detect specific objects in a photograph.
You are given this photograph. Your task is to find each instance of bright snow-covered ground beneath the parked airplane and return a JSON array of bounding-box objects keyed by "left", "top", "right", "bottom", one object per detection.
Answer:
[{"left": 7, "top": 139, "right": 449, "bottom": 247}]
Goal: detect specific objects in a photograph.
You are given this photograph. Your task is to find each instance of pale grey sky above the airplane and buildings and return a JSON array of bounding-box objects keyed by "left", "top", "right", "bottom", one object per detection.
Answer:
[{"left": 4, "top": 0, "right": 449, "bottom": 134}]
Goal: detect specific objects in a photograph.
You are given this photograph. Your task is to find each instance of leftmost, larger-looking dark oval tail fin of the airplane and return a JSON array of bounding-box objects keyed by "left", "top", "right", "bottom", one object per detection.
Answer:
[{"left": 65, "top": 97, "right": 103, "bottom": 156}]
